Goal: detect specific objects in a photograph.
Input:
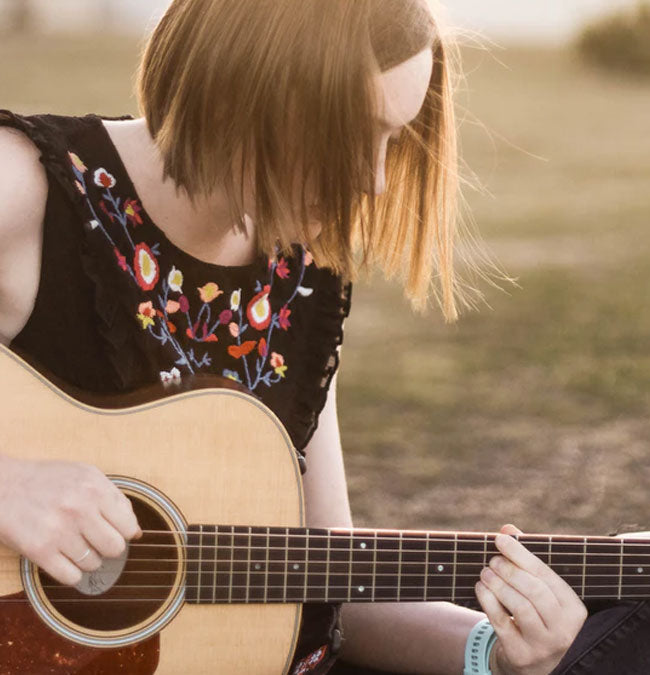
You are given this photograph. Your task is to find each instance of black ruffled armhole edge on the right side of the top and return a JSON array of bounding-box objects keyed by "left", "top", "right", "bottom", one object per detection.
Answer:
[{"left": 292, "top": 269, "right": 352, "bottom": 456}]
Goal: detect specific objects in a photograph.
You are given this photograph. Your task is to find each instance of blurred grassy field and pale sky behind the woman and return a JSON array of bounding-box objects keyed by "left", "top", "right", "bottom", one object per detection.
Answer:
[{"left": 0, "top": 0, "right": 650, "bottom": 534}]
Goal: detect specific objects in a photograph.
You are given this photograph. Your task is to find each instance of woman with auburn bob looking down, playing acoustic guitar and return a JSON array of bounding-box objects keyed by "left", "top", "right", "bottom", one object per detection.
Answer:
[{"left": 0, "top": 0, "right": 636, "bottom": 675}]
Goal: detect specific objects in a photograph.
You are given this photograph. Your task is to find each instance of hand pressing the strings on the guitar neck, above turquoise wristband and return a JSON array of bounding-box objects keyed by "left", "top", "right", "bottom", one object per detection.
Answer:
[{"left": 476, "top": 525, "right": 588, "bottom": 675}]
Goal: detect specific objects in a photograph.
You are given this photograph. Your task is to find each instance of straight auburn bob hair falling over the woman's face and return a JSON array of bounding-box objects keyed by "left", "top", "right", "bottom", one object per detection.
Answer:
[{"left": 136, "top": 0, "right": 461, "bottom": 321}]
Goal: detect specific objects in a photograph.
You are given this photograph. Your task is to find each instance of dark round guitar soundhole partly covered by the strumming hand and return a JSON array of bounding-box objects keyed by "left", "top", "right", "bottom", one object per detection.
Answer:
[{"left": 39, "top": 496, "right": 179, "bottom": 631}]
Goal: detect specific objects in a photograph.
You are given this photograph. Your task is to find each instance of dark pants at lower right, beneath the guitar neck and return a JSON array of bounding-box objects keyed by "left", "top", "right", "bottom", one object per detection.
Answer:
[{"left": 328, "top": 600, "right": 650, "bottom": 675}]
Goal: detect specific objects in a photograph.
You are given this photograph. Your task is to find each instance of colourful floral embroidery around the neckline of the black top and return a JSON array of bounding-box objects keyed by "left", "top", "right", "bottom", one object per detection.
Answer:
[{"left": 68, "top": 152, "right": 313, "bottom": 391}]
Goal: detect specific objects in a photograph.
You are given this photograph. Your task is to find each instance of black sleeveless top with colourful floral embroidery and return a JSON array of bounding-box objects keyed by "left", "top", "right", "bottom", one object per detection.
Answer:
[{"left": 0, "top": 110, "right": 352, "bottom": 675}]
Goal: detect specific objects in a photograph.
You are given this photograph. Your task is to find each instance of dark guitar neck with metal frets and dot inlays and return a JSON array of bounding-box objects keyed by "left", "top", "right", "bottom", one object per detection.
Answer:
[{"left": 181, "top": 525, "right": 650, "bottom": 604}]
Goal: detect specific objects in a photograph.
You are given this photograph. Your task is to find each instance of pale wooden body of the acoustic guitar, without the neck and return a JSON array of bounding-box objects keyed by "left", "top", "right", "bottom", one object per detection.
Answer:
[{"left": 0, "top": 346, "right": 304, "bottom": 675}]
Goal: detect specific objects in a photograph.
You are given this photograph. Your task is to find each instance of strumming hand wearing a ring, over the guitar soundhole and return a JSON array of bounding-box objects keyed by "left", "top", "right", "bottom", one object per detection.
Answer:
[{"left": 0, "top": 456, "right": 142, "bottom": 586}]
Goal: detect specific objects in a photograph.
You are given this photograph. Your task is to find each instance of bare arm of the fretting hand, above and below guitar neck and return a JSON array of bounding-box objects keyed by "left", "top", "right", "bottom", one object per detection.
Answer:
[{"left": 304, "top": 375, "right": 485, "bottom": 675}]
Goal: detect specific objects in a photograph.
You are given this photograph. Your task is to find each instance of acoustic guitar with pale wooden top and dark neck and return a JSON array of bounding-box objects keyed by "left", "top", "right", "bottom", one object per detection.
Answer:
[{"left": 0, "top": 345, "right": 650, "bottom": 675}]
